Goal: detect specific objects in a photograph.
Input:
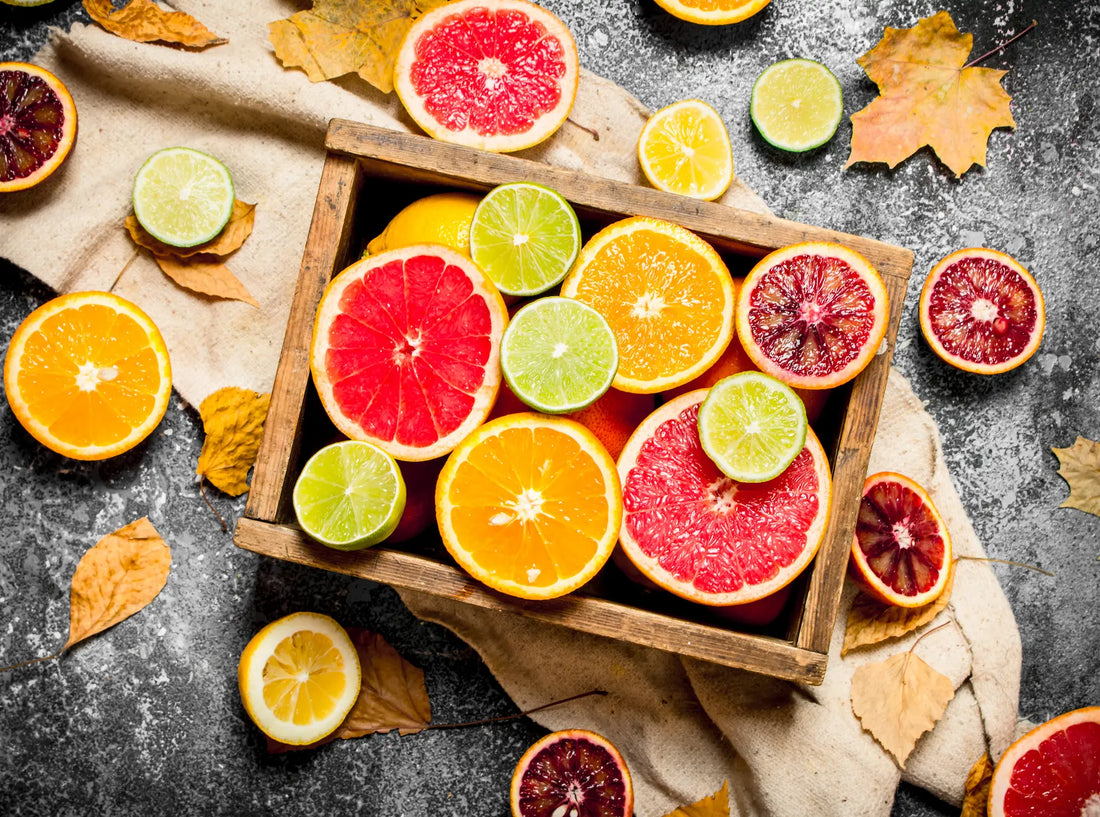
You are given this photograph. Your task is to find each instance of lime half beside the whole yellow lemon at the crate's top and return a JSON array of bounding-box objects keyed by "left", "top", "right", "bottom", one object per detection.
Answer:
[{"left": 470, "top": 181, "right": 581, "bottom": 296}]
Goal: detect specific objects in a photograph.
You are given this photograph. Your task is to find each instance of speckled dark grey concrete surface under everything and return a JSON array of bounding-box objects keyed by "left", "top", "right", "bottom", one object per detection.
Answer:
[{"left": 0, "top": 0, "right": 1100, "bottom": 817}]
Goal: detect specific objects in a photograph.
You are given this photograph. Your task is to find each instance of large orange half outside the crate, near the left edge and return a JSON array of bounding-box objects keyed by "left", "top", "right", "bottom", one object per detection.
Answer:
[{"left": 3, "top": 292, "right": 172, "bottom": 460}]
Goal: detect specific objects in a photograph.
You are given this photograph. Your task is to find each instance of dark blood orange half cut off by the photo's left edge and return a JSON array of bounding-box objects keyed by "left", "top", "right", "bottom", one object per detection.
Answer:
[{"left": 0, "top": 63, "right": 76, "bottom": 192}]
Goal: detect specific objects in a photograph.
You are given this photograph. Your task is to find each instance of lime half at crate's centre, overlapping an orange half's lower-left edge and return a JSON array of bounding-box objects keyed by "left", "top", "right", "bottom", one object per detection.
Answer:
[{"left": 501, "top": 297, "right": 618, "bottom": 415}]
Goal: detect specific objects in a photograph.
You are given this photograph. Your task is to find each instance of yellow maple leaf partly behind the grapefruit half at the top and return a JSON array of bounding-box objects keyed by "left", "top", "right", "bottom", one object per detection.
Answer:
[{"left": 267, "top": 0, "right": 447, "bottom": 93}]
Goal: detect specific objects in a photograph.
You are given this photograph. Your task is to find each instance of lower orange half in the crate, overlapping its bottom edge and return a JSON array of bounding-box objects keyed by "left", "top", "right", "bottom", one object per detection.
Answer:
[{"left": 436, "top": 412, "right": 623, "bottom": 599}]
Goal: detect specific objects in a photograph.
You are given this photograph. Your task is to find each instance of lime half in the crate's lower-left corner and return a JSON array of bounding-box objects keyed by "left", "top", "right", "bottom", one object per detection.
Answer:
[{"left": 293, "top": 440, "right": 405, "bottom": 550}]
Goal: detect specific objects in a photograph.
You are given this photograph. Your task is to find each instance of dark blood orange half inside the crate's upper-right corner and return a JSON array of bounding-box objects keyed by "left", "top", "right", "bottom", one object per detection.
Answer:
[{"left": 737, "top": 242, "right": 890, "bottom": 388}]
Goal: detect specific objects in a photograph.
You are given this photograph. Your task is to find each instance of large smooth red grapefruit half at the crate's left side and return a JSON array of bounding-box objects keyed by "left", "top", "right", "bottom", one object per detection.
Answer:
[{"left": 310, "top": 244, "right": 508, "bottom": 461}]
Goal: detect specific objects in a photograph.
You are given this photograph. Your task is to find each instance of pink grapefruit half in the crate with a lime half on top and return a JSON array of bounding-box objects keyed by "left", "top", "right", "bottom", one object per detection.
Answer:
[{"left": 618, "top": 389, "right": 832, "bottom": 606}]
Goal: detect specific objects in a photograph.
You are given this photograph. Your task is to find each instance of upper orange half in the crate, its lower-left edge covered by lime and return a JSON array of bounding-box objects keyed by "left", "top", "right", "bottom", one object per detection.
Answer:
[{"left": 561, "top": 217, "right": 736, "bottom": 394}]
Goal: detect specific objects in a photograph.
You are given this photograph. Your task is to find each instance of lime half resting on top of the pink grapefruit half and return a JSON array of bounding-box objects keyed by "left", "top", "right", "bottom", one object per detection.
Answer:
[{"left": 699, "top": 372, "right": 807, "bottom": 483}]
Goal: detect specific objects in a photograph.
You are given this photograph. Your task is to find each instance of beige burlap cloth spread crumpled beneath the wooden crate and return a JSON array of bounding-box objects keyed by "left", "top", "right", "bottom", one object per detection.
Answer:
[{"left": 0, "top": 0, "right": 1021, "bottom": 817}]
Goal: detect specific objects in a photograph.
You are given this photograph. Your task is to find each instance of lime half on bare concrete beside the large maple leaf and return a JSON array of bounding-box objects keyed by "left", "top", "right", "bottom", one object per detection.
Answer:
[{"left": 749, "top": 59, "right": 844, "bottom": 153}]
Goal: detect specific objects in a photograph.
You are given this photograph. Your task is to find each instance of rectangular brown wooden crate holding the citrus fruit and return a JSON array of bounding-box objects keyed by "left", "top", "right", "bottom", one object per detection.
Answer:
[{"left": 234, "top": 120, "right": 913, "bottom": 684}]
